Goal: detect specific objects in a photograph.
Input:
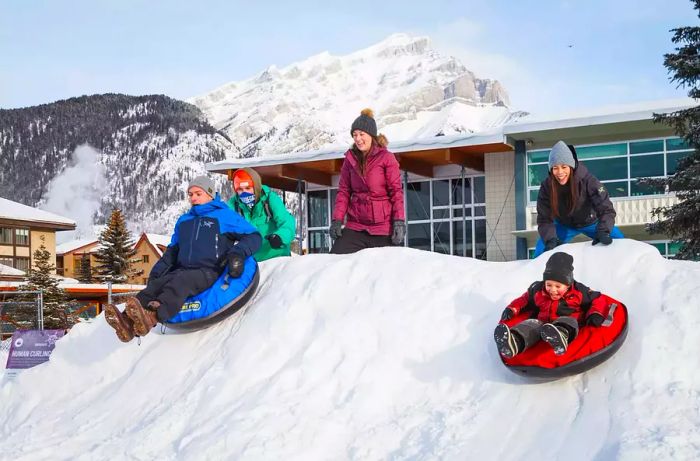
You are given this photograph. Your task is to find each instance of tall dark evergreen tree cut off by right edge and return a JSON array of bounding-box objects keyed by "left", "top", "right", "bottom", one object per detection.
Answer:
[{"left": 644, "top": 0, "right": 700, "bottom": 260}]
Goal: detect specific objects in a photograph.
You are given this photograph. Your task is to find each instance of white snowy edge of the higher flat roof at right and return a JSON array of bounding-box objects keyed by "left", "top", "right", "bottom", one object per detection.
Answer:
[{"left": 503, "top": 98, "right": 698, "bottom": 135}]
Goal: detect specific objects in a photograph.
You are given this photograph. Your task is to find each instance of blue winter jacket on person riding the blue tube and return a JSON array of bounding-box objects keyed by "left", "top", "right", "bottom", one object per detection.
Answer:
[{"left": 151, "top": 194, "right": 262, "bottom": 278}]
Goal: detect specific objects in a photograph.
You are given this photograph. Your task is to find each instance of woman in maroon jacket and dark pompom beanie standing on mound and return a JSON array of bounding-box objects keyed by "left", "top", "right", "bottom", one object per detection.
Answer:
[{"left": 329, "top": 109, "right": 406, "bottom": 254}]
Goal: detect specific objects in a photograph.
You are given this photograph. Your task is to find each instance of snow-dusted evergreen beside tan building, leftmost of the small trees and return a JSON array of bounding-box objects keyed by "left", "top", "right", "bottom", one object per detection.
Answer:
[{"left": 20, "top": 236, "right": 75, "bottom": 329}]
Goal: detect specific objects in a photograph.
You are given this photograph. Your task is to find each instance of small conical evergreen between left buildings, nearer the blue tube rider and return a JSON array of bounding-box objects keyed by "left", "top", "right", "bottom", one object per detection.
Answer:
[{"left": 95, "top": 208, "right": 137, "bottom": 283}]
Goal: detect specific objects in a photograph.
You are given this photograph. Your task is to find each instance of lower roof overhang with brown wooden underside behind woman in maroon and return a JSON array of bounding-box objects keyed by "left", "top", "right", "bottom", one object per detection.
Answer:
[{"left": 207, "top": 129, "right": 513, "bottom": 191}]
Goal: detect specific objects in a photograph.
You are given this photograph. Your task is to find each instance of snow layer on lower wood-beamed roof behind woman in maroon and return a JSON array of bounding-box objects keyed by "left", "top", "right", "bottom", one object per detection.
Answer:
[{"left": 206, "top": 128, "right": 505, "bottom": 172}]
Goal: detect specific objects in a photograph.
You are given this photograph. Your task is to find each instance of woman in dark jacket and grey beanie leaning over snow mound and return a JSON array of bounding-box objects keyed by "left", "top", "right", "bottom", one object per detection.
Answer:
[{"left": 535, "top": 141, "right": 624, "bottom": 256}]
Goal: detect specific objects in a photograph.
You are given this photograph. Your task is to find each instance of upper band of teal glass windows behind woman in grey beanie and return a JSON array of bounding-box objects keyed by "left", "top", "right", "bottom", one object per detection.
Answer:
[{"left": 526, "top": 137, "right": 693, "bottom": 204}]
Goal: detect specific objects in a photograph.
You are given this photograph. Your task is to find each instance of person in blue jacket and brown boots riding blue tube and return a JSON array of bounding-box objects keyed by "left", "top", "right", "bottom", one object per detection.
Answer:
[{"left": 105, "top": 176, "right": 262, "bottom": 342}]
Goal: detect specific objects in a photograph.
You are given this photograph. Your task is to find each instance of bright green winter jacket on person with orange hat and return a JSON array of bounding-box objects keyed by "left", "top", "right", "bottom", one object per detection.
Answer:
[{"left": 227, "top": 186, "right": 296, "bottom": 261}]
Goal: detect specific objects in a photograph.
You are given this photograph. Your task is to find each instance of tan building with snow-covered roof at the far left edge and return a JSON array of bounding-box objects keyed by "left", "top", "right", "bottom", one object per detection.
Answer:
[{"left": 0, "top": 198, "right": 76, "bottom": 272}]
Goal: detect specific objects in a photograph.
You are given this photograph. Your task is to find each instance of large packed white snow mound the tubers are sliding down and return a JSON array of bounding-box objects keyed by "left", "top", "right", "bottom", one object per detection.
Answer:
[{"left": 0, "top": 240, "right": 700, "bottom": 461}]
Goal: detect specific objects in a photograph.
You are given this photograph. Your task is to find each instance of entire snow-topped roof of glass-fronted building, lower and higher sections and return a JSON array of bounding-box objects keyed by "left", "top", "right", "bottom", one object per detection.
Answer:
[{"left": 206, "top": 98, "right": 697, "bottom": 190}]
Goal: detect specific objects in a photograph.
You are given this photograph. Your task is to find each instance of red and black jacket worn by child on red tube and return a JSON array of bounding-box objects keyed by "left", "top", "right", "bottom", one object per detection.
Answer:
[{"left": 508, "top": 282, "right": 609, "bottom": 323}]
